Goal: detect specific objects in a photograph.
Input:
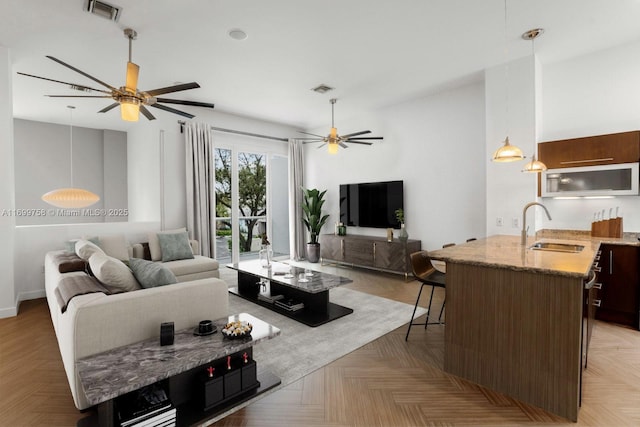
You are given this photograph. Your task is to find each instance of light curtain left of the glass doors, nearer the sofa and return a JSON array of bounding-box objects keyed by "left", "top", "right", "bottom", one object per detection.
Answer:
[{"left": 184, "top": 122, "right": 216, "bottom": 257}]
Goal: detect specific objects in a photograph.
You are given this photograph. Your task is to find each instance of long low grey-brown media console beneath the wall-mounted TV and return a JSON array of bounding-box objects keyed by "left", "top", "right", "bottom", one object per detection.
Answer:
[{"left": 320, "top": 234, "right": 422, "bottom": 278}]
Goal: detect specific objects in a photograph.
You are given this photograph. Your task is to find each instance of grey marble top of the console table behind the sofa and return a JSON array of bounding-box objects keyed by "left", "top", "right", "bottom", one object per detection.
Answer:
[{"left": 76, "top": 313, "right": 280, "bottom": 405}]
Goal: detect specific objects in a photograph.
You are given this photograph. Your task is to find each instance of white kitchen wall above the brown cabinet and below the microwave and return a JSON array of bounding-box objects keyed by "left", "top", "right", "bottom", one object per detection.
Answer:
[{"left": 540, "top": 41, "right": 640, "bottom": 232}]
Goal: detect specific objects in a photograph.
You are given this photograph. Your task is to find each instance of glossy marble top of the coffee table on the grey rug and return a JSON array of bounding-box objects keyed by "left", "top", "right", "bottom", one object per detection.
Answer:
[{"left": 227, "top": 260, "right": 352, "bottom": 294}]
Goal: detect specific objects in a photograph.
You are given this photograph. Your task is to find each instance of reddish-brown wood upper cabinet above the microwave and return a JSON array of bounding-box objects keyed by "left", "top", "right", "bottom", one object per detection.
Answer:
[{"left": 538, "top": 131, "right": 640, "bottom": 169}]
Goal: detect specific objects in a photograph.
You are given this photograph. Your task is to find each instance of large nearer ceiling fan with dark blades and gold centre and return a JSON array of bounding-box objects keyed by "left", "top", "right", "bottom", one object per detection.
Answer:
[{"left": 18, "top": 28, "right": 214, "bottom": 121}]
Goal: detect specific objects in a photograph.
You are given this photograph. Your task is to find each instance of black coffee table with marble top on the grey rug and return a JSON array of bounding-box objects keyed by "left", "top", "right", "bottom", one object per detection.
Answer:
[{"left": 227, "top": 260, "right": 353, "bottom": 327}]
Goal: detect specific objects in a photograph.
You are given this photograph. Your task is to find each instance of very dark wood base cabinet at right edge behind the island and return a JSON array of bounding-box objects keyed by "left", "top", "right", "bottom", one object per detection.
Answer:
[{"left": 596, "top": 244, "right": 640, "bottom": 329}]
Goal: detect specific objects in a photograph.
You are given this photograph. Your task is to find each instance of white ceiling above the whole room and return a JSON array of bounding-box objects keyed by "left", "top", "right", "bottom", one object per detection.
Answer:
[{"left": 0, "top": 0, "right": 640, "bottom": 130}]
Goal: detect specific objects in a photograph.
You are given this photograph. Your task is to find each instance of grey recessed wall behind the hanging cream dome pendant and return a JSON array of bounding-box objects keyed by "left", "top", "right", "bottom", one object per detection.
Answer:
[{"left": 14, "top": 119, "right": 127, "bottom": 225}]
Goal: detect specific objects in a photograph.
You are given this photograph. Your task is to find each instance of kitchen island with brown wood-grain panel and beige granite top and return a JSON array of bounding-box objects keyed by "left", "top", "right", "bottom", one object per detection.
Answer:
[{"left": 429, "top": 236, "right": 599, "bottom": 421}]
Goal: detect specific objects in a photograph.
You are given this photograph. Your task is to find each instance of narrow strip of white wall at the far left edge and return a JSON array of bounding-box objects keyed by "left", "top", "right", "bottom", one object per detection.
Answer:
[{"left": 0, "top": 46, "right": 17, "bottom": 318}]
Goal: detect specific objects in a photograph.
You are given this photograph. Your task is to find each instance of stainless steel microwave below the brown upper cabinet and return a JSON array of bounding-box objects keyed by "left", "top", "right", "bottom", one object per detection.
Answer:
[{"left": 541, "top": 163, "right": 640, "bottom": 197}]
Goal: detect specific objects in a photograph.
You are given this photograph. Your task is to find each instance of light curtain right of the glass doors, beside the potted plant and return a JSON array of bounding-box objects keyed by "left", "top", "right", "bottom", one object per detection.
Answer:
[{"left": 289, "top": 139, "right": 306, "bottom": 261}]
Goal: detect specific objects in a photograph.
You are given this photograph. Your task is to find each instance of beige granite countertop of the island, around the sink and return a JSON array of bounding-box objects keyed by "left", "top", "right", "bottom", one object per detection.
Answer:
[{"left": 429, "top": 235, "right": 609, "bottom": 278}]
